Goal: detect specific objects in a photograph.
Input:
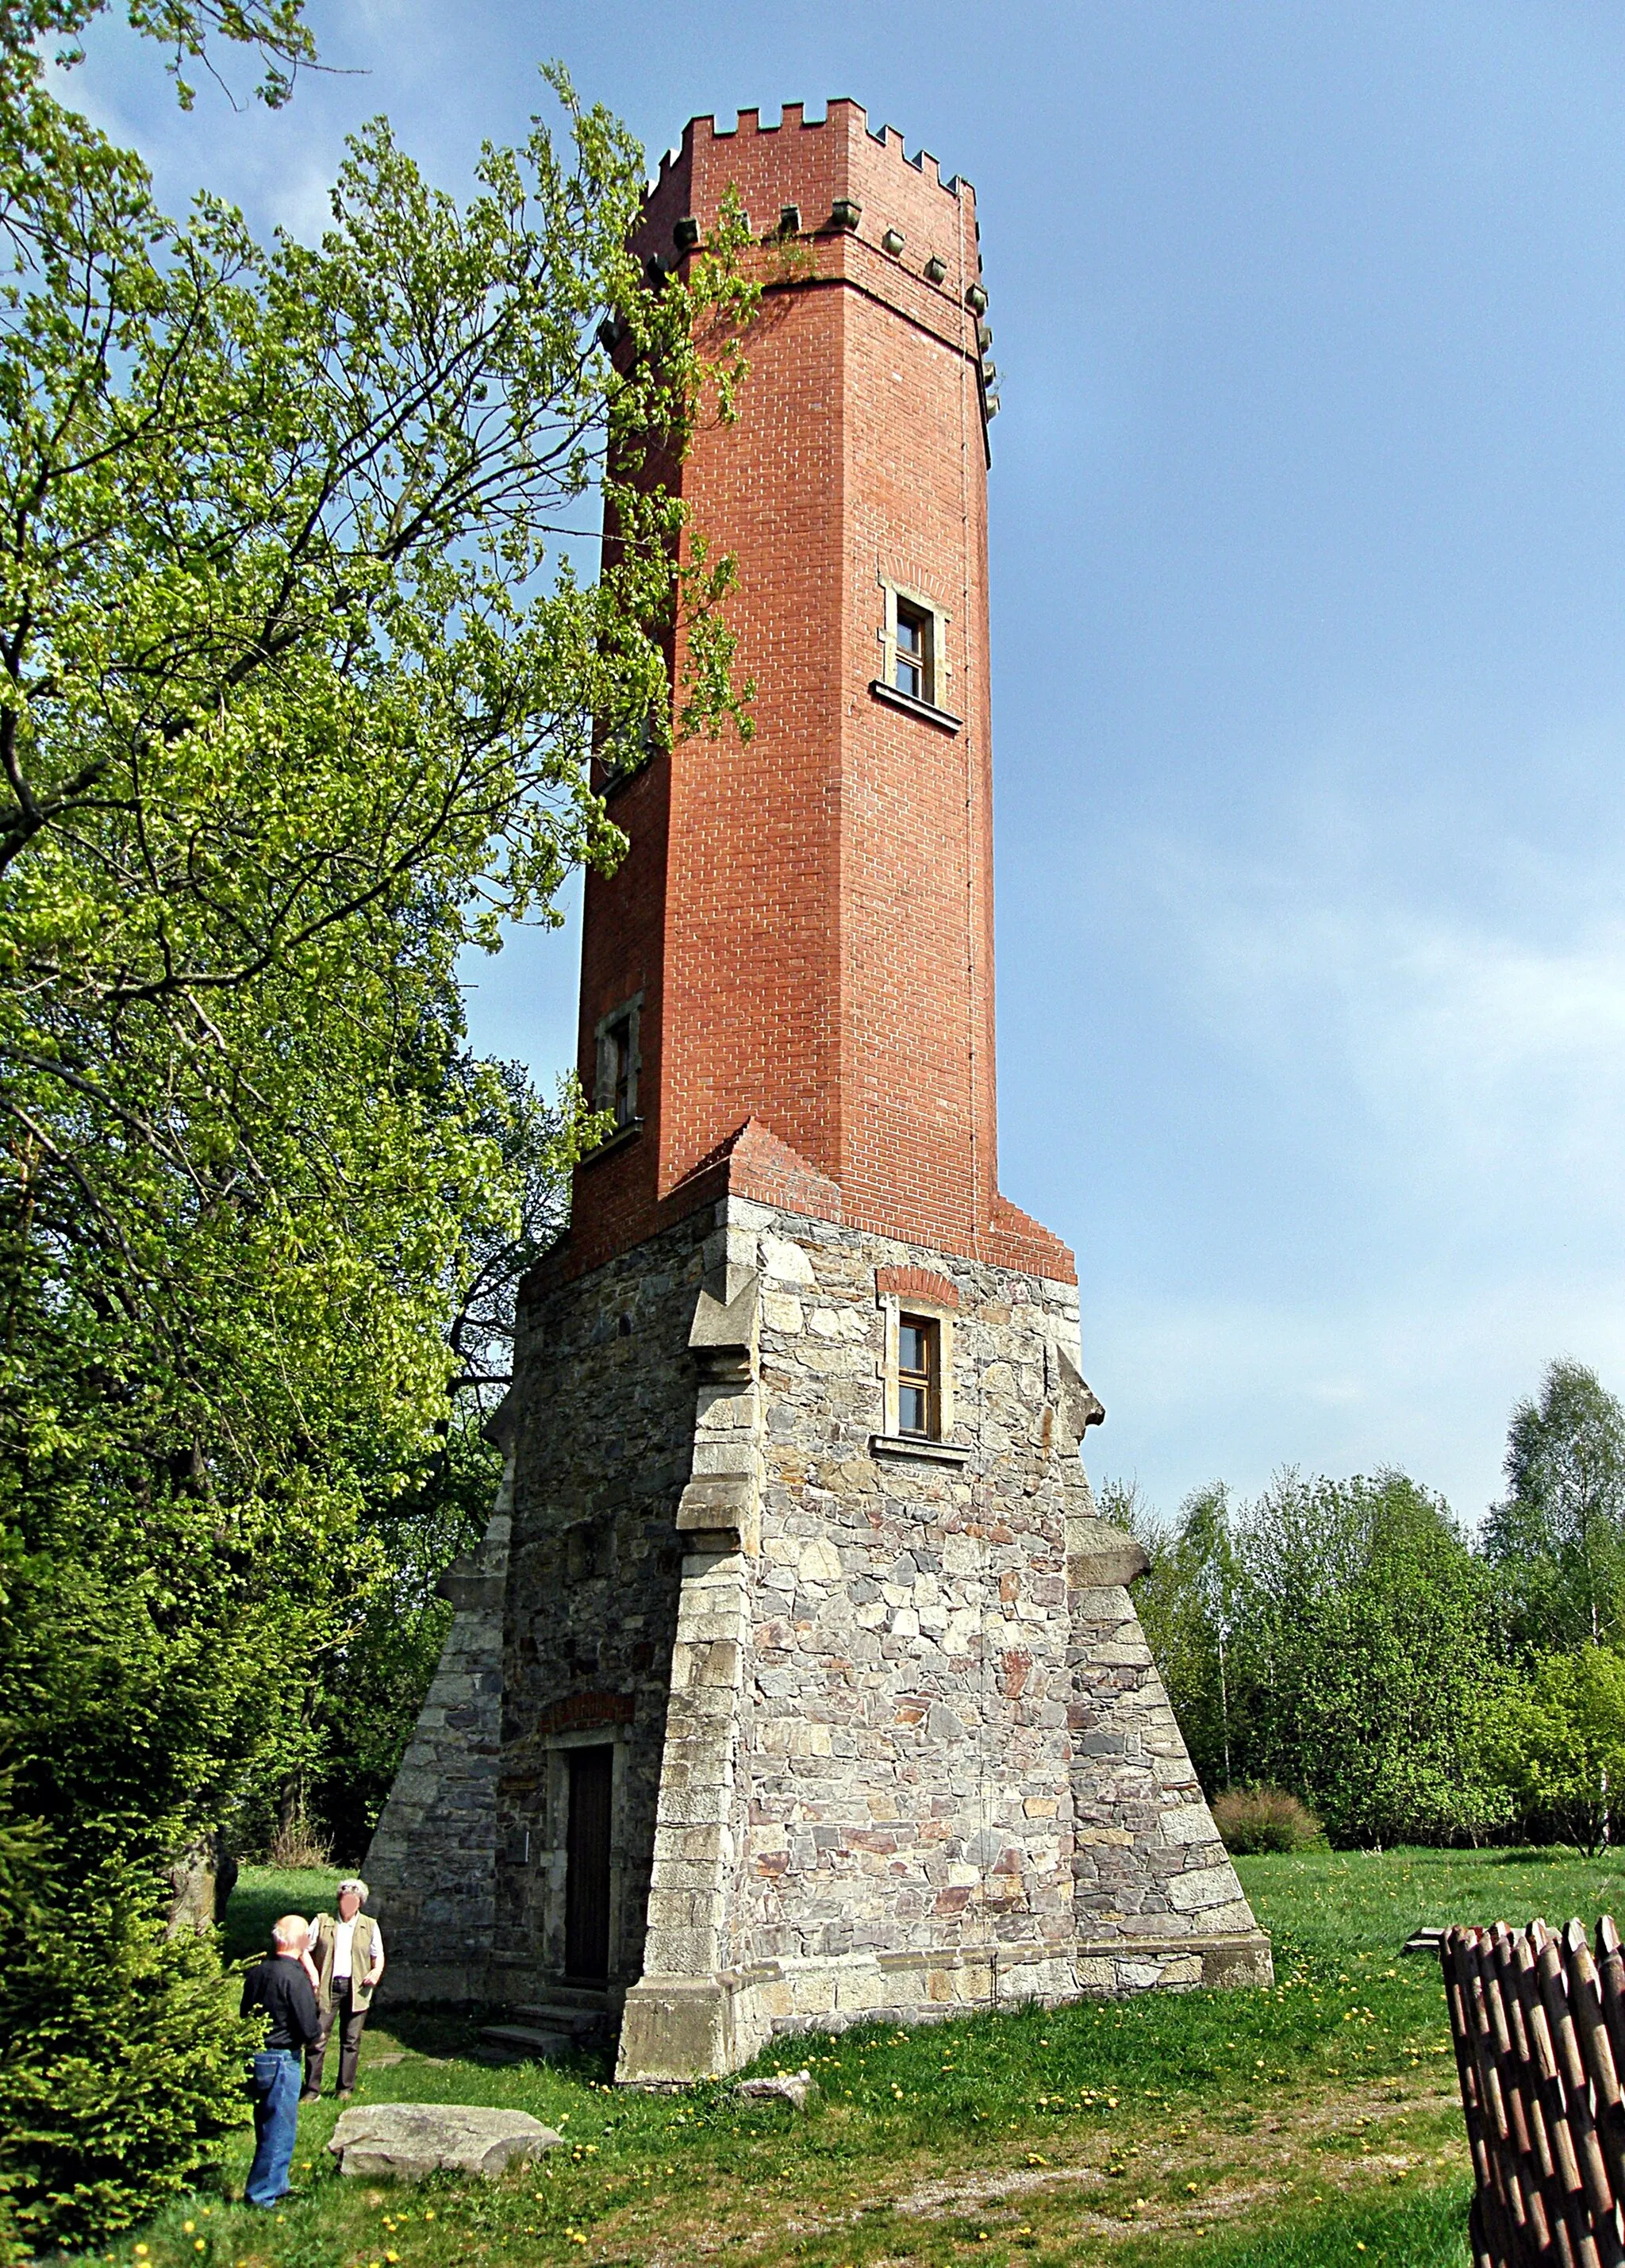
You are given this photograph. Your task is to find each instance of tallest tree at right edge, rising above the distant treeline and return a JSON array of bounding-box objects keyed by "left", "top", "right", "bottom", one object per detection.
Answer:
[{"left": 1485, "top": 1361, "right": 1625, "bottom": 1651}]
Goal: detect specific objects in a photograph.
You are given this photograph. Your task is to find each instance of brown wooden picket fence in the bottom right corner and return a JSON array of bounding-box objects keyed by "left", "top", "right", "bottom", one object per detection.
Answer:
[{"left": 1439, "top": 1914, "right": 1625, "bottom": 2268}]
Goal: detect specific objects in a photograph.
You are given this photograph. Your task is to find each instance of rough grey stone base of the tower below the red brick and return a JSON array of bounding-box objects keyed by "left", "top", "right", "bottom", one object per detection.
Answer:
[{"left": 374, "top": 1143, "right": 1271, "bottom": 2050}]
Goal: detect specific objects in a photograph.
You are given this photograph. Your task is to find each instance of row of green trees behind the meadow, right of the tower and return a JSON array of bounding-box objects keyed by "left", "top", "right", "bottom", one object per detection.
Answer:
[{"left": 1128, "top": 1361, "right": 1625, "bottom": 1844}]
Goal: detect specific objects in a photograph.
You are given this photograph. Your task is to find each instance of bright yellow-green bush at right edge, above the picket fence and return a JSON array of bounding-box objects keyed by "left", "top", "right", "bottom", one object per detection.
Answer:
[{"left": 1485, "top": 1647, "right": 1625, "bottom": 1851}]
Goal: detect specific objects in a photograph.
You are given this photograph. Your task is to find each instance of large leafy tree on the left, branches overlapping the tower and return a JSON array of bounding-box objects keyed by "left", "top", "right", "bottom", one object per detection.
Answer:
[{"left": 0, "top": 0, "right": 750, "bottom": 2236}]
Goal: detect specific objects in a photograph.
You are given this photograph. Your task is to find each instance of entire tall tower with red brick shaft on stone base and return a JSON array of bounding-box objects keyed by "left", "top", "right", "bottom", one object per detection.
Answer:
[{"left": 370, "top": 102, "right": 1270, "bottom": 2082}]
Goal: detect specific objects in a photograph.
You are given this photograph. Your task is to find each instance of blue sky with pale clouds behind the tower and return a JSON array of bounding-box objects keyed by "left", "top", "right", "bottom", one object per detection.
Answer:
[{"left": 75, "top": 0, "right": 1625, "bottom": 1520}]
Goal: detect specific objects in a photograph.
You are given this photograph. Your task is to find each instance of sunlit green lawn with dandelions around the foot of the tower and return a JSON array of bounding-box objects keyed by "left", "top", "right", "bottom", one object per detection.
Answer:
[{"left": 116, "top": 1851, "right": 1625, "bottom": 2268}]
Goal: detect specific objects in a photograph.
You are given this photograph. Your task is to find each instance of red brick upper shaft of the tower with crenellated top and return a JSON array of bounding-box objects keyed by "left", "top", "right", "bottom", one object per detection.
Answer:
[{"left": 564, "top": 102, "right": 1072, "bottom": 1277}]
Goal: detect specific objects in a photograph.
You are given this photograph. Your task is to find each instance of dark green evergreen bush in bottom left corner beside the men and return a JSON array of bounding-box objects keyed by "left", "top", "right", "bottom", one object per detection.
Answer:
[{"left": 0, "top": 1848, "right": 254, "bottom": 2252}]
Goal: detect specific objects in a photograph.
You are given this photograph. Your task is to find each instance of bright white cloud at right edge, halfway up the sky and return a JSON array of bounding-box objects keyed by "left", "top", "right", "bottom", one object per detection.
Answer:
[{"left": 1135, "top": 784, "right": 1625, "bottom": 1222}]
